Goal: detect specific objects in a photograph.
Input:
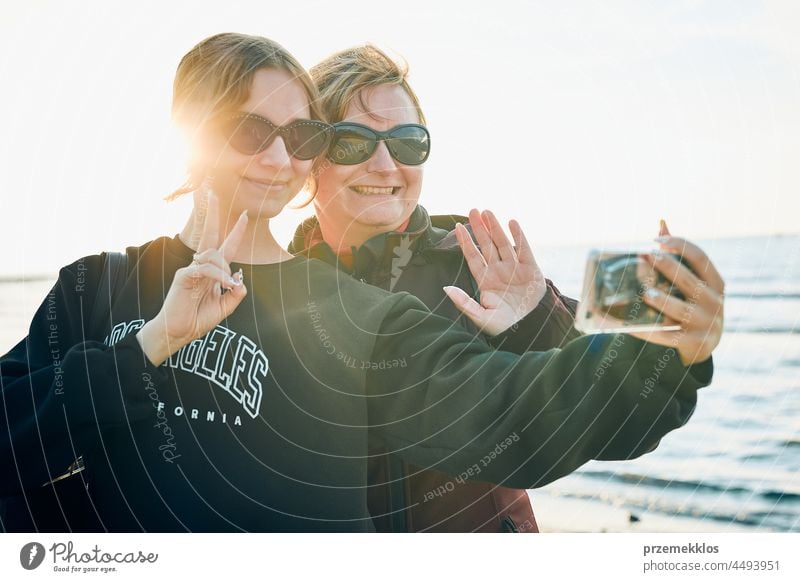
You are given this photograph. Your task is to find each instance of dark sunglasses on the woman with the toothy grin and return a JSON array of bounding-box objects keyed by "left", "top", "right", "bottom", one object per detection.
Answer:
[{"left": 328, "top": 121, "right": 431, "bottom": 166}]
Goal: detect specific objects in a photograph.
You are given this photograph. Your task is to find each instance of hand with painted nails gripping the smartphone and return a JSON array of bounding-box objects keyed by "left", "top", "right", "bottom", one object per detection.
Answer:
[{"left": 632, "top": 221, "right": 725, "bottom": 366}]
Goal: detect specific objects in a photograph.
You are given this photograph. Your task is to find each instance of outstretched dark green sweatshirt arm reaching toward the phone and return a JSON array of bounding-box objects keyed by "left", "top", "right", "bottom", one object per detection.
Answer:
[{"left": 368, "top": 237, "right": 722, "bottom": 488}]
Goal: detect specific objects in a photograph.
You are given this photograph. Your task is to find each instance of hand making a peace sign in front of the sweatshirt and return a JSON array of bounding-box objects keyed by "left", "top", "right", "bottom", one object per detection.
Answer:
[{"left": 136, "top": 194, "right": 247, "bottom": 365}]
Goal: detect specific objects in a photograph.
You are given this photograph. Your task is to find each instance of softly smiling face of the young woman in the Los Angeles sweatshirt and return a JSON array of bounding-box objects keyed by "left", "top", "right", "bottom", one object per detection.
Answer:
[{"left": 200, "top": 69, "right": 313, "bottom": 219}]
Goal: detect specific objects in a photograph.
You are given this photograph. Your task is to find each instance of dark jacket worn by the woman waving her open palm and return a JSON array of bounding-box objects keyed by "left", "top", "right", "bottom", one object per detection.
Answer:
[{"left": 289, "top": 206, "right": 704, "bottom": 532}]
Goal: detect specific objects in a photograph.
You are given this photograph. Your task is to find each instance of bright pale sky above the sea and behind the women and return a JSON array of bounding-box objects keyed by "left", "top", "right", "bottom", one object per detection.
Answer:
[{"left": 0, "top": 0, "right": 800, "bottom": 276}]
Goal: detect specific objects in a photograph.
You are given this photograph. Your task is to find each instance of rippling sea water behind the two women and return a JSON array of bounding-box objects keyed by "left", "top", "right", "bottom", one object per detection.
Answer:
[{"left": 0, "top": 236, "right": 800, "bottom": 531}]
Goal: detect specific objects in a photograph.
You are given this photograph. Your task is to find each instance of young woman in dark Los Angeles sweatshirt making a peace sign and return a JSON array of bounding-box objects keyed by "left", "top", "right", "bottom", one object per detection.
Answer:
[{"left": 0, "top": 34, "right": 721, "bottom": 531}]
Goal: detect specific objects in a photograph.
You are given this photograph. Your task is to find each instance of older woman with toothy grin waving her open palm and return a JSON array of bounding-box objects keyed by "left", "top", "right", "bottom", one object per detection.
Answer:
[{"left": 290, "top": 46, "right": 719, "bottom": 532}]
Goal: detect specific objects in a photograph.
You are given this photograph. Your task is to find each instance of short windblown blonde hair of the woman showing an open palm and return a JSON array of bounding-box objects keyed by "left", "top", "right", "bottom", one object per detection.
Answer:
[{"left": 310, "top": 44, "right": 425, "bottom": 125}]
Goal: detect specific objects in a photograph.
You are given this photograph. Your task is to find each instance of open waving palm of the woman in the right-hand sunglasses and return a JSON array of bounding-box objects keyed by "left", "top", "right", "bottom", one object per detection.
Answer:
[{"left": 444, "top": 209, "right": 547, "bottom": 335}]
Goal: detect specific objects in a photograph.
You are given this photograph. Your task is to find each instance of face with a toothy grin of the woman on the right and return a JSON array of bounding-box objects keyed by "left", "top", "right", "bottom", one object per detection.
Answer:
[{"left": 314, "top": 85, "right": 423, "bottom": 248}]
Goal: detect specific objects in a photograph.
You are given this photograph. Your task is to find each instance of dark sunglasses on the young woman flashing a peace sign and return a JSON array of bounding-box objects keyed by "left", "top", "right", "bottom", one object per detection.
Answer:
[{"left": 221, "top": 113, "right": 333, "bottom": 160}]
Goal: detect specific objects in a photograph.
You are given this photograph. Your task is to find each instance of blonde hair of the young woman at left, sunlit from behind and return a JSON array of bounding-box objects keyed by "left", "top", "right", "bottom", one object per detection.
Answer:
[{"left": 166, "top": 32, "right": 325, "bottom": 200}]
